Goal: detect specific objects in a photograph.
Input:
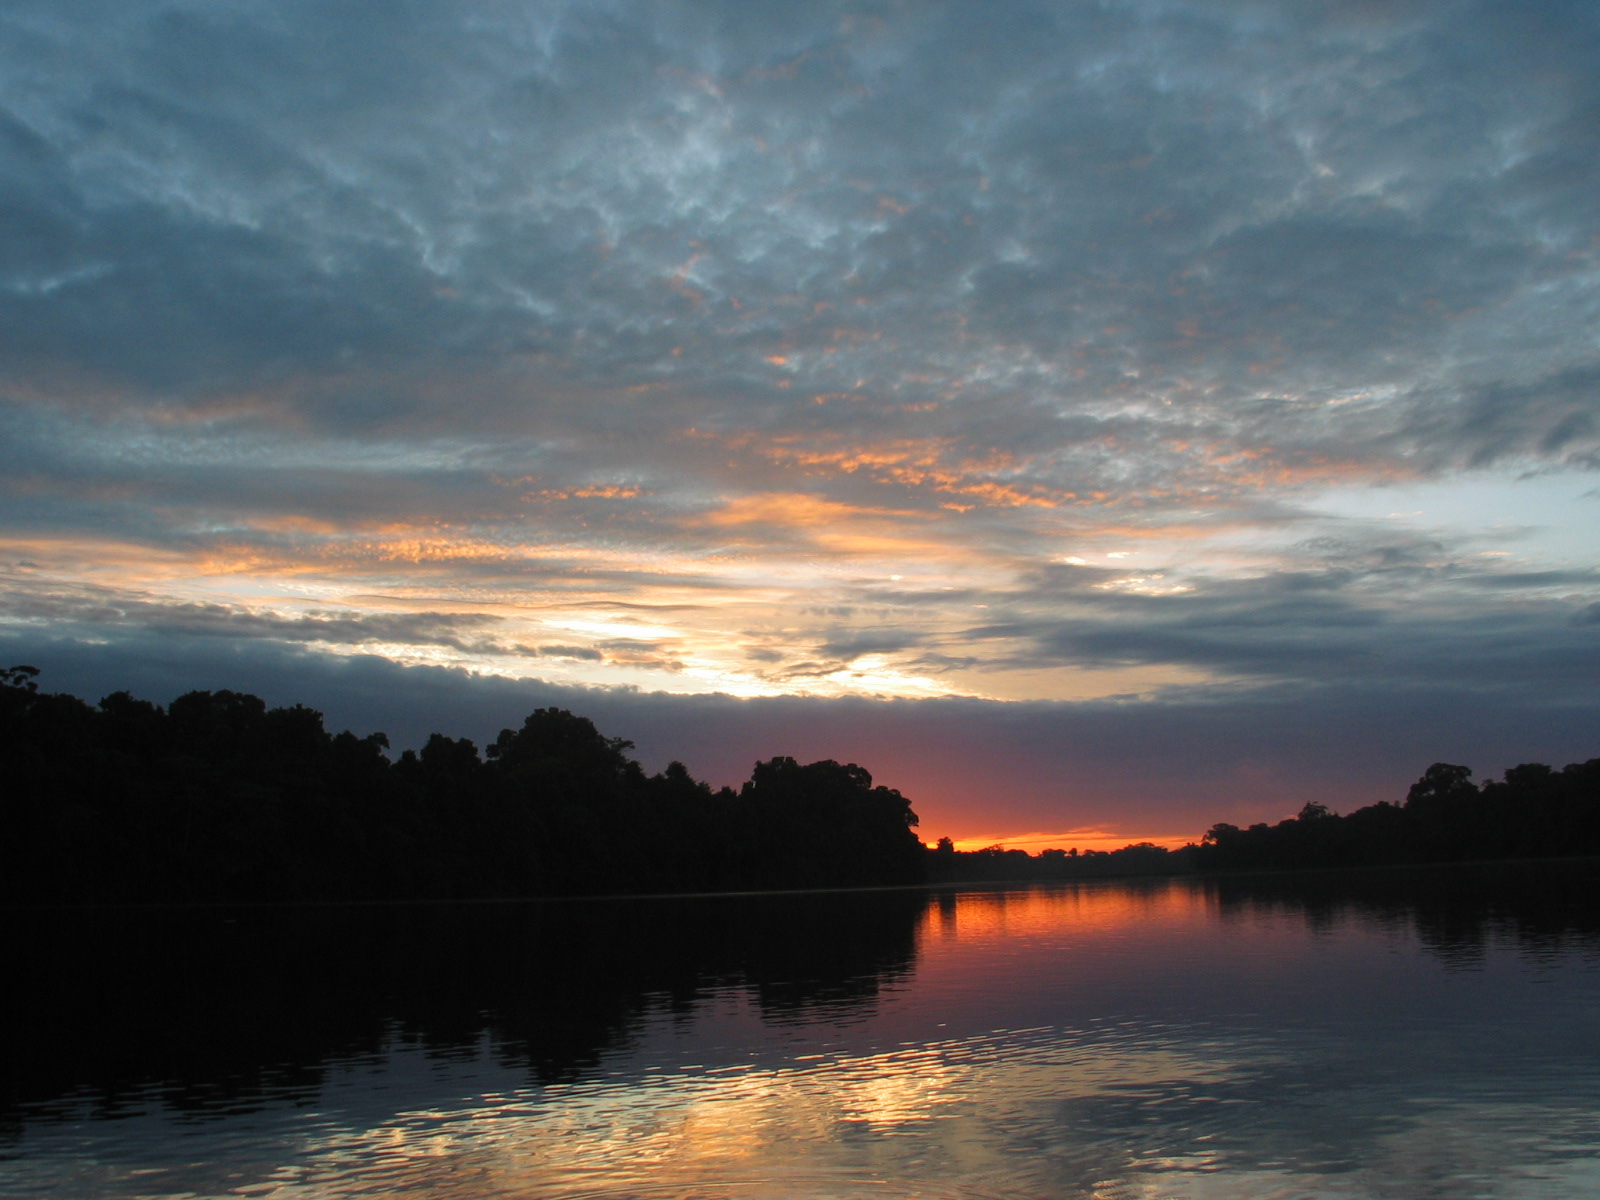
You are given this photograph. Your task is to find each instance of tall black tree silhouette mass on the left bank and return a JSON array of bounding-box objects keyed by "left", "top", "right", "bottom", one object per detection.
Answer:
[{"left": 0, "top": 667, "right": 926, "bottom": 904}]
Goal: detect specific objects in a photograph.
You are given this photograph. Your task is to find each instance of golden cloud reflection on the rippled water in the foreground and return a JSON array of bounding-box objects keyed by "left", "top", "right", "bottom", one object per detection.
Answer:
[{"left": 228, "top": 966, "right": 1230, "bottom": 1200}]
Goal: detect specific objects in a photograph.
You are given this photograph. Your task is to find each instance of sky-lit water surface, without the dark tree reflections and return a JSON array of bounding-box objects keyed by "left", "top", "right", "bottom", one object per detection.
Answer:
[{"left": 8, "top": 880, "right": 1600, "bottom": 1200}]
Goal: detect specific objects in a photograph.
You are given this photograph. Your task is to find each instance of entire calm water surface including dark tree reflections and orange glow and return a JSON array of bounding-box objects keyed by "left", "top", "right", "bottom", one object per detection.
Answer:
[{"left": 0, "top": 862, "right": 1600, "bottom": 1200}]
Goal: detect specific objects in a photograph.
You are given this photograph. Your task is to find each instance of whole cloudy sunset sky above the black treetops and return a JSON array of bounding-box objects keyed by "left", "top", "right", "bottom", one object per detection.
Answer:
[{"left": 0, "top": 0, "right": 1600, "bottom": 848}]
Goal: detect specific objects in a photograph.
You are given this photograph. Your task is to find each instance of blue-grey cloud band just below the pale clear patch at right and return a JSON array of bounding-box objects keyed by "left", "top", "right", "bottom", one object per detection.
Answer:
[{"left": 974, "top": 550, "right": 1600, "bottom": 691}]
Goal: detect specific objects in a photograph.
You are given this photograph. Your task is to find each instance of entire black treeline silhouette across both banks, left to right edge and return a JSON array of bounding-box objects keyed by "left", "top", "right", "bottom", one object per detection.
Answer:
[{"left": 0, "top": 667, "right": 1600, "bottom": 904}]
